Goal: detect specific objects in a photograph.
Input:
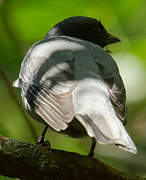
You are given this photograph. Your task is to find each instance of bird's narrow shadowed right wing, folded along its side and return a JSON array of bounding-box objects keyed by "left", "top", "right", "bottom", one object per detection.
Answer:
[{"left": 96, "top": 50, "right": 127, "bottom": 125}]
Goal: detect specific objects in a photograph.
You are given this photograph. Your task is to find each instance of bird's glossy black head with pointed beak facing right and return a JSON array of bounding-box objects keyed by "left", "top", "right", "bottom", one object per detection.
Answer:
[{"left": 44, "top": 16, "right": 120, "bottom": 47}]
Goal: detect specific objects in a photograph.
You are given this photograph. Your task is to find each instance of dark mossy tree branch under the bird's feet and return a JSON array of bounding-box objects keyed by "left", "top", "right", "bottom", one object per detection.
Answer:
[{"left": 0, "top": 136, "right": 145, "bottom": 180}]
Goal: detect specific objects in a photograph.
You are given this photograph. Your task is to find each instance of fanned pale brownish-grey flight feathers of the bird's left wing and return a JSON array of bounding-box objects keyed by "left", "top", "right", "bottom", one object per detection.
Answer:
[{"left": 26, "top": 85, "right": 74, "bottom": 131}]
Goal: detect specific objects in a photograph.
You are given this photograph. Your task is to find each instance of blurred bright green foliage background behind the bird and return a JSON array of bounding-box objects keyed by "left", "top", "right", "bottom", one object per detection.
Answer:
[{"left": 0, "top": 0, "right": 146, "bottom": 180}]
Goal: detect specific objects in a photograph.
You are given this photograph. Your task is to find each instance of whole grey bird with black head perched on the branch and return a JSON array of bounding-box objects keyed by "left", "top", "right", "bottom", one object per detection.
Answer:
[{"left": 13, "top": 16, "right": 137, "bottom": 157}]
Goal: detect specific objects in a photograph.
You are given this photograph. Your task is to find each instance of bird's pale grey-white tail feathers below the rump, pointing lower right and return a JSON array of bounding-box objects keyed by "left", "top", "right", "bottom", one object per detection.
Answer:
[{"left": 76, "top": 114, "right": 137, "bottom": 154}]
